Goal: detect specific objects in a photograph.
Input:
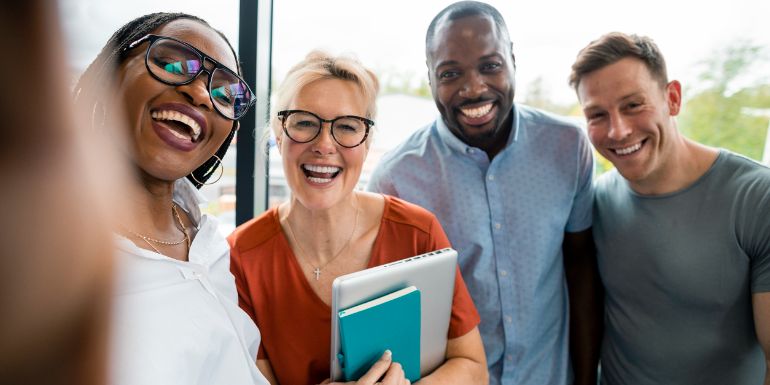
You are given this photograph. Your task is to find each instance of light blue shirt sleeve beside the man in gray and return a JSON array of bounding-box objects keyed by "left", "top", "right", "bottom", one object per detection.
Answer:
[{"left": 565, "top": 129, "right": 594, "bottom": 233}]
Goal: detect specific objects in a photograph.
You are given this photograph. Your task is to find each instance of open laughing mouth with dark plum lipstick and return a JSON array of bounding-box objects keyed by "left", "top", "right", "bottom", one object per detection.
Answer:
[{"left": 150, "top": 103, "right": 207, "bottom": 151}]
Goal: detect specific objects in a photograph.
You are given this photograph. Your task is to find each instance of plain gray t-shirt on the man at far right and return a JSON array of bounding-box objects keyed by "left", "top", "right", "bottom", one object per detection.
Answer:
[{"left": 594, "top": 150, "right": 770, "bottom": 385}]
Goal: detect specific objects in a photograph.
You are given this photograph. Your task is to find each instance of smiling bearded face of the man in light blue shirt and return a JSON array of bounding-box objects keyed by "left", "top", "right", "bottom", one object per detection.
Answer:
[{"left": 427, "top": 16, "right": 515, "bottom": 155}]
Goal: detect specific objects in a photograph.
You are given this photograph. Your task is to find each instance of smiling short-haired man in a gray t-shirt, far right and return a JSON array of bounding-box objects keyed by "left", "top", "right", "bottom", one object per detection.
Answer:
[{"left": 570, "top": 33, "right": 770, "bottom": 385}]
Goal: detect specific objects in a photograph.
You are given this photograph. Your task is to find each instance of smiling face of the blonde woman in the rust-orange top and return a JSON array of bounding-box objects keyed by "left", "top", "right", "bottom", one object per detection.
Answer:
[{"left": 277, "top": 79, "right": 368, "bottom": 210}]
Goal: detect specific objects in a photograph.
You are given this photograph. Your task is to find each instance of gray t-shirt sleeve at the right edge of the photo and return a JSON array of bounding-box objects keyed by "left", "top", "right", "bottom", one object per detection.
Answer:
[{"left": 738, "top": 170, "right": 770, "bottom": 293}]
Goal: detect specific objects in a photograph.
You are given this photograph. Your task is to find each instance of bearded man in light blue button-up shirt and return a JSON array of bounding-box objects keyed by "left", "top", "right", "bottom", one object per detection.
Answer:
[{"left": 369, "top": 2, "right": 602, "bottom": 385}]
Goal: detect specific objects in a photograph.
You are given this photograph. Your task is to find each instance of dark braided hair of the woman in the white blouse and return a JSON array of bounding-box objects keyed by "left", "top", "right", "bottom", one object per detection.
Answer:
[{"left": 73, "top": 12, "right": 241, "bottom": 188}]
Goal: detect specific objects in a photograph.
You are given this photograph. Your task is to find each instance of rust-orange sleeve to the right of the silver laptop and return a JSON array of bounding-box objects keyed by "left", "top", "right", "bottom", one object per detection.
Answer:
[{"left": 430, "top": 216, "right": 481, "bottom": 339}]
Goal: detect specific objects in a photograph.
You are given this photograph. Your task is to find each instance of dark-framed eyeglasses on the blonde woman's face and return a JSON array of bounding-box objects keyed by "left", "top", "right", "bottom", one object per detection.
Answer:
[{"left": 278, "top": 110, "right": 374, "bottom": 148}]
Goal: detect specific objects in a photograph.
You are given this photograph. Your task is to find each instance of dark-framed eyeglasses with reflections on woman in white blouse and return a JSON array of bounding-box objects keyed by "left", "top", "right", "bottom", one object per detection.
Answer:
[{"left": 124, "top": 34, "right": 257, "bottom": 120}]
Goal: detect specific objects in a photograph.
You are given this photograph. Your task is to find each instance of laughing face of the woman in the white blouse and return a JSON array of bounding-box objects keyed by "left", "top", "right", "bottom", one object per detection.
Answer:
[{"left": 118, "top": 19, "right": 237, "bottom": 181}]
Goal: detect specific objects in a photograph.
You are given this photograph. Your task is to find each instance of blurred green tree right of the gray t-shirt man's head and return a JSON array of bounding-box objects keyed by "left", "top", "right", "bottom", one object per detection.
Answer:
[{"left": 679, "top": 42, "right": 770, "bottom": 160}]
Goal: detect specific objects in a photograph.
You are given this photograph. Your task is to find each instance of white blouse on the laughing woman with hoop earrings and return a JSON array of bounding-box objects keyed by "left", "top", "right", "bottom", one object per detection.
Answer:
[{"left": 111, "top": 179, "right": 267, "bottom": 385}]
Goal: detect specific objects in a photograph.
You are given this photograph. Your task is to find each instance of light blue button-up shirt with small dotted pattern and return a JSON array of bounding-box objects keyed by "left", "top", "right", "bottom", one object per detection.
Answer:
[{"left": 368, "top": 105, "right": 593, "bottom": 385}]
